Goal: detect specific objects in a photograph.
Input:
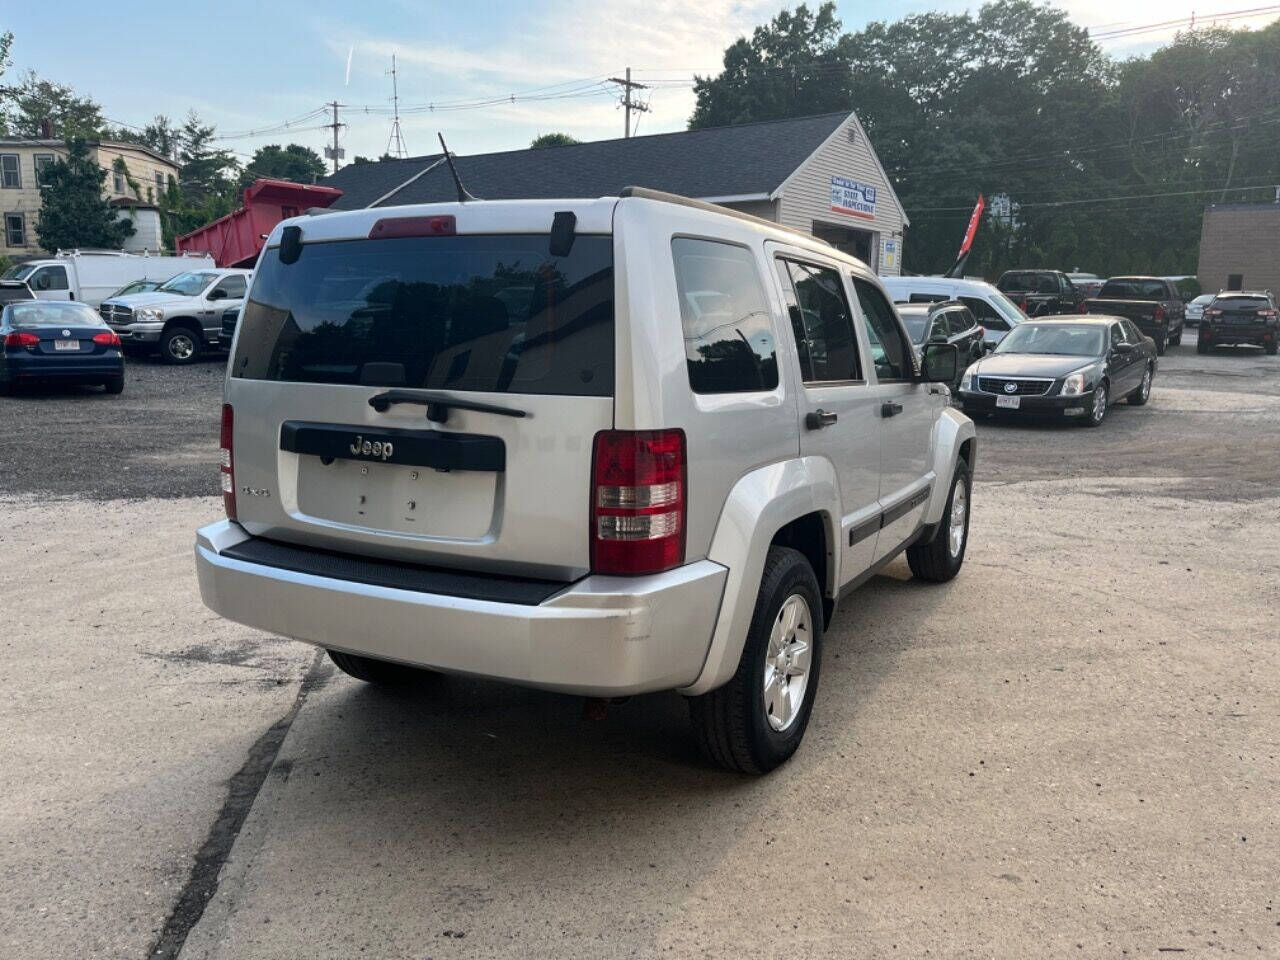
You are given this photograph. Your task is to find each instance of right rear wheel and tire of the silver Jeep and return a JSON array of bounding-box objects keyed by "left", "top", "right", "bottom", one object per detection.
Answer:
[{"left": 689, "top": 547, "right": 823, "bottom": 773}]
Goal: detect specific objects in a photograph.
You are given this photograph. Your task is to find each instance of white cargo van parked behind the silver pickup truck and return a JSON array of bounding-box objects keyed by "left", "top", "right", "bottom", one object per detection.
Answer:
[{"left": 0, "top": 250, "right": 214, "bottom": 310}]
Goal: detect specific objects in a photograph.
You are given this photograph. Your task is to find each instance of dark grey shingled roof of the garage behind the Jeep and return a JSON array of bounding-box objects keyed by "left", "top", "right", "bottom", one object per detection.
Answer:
[{"left": 320, "top": 113, "right": 849, "bottom": 210}]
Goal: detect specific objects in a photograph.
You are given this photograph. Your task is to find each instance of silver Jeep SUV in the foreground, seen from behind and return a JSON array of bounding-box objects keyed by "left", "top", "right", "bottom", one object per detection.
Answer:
[{"left": 196, "top": 188, "right": 977, "bottom": 773}]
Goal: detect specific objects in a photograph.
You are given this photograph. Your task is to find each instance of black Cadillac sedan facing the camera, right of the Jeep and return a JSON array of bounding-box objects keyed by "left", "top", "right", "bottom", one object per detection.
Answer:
[{"left": 960, "top": 316, "right": 1157, "bottom": 426}]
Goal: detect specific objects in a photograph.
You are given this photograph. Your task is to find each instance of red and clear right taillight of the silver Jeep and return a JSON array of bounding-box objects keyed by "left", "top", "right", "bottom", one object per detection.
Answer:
[{"left": 591, "top": 430, "right": 686, "bottom": 576}]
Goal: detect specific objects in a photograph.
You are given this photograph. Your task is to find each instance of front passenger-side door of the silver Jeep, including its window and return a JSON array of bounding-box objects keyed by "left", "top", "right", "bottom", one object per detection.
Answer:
[{"left": 852, "top": 276, "right": 947, "bottom": 559}]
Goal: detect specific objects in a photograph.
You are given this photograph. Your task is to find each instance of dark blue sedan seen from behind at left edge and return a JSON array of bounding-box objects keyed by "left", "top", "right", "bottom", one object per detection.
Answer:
[{"left": 0, "top": 300, "right": 124, "bottom": 393}]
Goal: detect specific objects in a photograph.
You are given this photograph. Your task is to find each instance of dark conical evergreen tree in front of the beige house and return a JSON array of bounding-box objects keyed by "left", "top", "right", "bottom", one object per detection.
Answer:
[{"left": 36, "top": 137, "right": 133, "bottom": 250}]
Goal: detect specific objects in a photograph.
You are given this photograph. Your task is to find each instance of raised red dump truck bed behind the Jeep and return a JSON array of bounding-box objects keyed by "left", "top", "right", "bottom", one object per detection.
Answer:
[{"left": 175, "top": 179, "right": 342, "bottom": 268}]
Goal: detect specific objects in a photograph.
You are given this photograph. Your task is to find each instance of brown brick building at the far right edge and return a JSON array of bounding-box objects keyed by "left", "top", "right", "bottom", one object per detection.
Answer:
[{"left": 1197, "top": 201, "right": 1280, "bottom": 293}]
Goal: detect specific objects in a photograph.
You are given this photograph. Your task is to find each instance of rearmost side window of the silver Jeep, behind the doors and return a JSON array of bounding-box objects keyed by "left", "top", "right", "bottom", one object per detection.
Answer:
[{"left": 670, "top": 237, "right": 778, "bottom": 393}]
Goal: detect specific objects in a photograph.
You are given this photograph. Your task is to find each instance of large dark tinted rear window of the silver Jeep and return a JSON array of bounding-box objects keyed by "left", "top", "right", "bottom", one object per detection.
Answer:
[{"left": 232, "top": 234, "right": 613, "bottom": 397}]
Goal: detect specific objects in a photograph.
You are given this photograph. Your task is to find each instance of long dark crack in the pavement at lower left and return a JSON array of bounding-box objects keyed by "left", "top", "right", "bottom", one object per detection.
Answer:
[{"left": 147, "top": 649, "right": 333, "bottom": 960}]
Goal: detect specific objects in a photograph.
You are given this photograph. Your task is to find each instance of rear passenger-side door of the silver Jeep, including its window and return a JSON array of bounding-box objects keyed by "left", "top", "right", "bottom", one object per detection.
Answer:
[{"left": 771, "top": 252, "right": 881, "bottom": 584}]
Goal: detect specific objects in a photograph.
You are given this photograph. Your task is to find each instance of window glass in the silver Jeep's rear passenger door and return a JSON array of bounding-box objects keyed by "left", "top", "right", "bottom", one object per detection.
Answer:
[{"left": 778, "top": 260, "right": 861, "bottom": 383}]
